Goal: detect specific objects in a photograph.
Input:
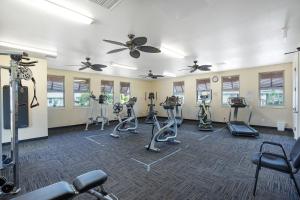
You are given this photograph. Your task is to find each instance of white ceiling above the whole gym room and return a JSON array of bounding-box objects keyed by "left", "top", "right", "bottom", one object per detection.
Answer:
[{"left": 0, "top": 0, "right": 300, "bottom": 77}]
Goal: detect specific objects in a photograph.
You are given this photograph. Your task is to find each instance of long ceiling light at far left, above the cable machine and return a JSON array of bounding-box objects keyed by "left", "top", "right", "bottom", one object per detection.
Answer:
[{"left": 0, "top": 41, "right": 57, "bottom": 57}]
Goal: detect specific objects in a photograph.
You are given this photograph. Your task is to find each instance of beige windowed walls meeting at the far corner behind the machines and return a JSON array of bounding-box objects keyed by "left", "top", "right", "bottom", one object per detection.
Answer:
[{"left": 48, "top": 63, "right": 292, "bottom": 128}]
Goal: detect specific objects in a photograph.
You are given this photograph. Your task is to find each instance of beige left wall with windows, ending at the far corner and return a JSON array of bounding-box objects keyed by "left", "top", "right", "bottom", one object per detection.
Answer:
[{"left": 48, "top": 69, "right": 151, "bottom": 128}]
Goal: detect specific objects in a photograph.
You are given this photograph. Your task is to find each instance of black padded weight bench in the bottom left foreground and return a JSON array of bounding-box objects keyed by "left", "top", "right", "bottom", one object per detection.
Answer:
[{"left": 12, "top": 170, "right": 107, "bottom": 200}]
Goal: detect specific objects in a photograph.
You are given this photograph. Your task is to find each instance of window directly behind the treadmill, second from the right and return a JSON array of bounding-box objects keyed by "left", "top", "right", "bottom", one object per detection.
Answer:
[{"left": 222, "top": 76, "right": 240, "bottom": 105}]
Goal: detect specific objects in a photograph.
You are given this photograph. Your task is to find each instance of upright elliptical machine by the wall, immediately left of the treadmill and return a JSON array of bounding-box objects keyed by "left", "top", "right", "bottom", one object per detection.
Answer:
[{"left": 198, "top": 90, "right": 213, "bottom": 131}]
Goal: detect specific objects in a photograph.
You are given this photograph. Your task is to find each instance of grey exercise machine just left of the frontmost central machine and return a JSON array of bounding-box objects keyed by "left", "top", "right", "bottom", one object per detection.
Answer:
[{"left": 110, "top": 97, "right": 138, "bottom": 138}]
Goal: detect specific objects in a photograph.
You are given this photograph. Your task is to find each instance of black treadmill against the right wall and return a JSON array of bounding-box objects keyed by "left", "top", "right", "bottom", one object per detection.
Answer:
[{"left": 227, "top": 97, "right": 259, "bottom": 137}]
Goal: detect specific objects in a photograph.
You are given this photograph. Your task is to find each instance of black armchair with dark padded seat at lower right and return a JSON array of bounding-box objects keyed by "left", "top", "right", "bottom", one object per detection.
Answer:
[{"left": 252, "top": 138, "right": 300, "bottom": 196}]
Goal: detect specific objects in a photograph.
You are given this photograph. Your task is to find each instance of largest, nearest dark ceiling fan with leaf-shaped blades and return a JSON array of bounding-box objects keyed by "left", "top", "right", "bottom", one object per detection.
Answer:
[{"left": 103, "top": 34, "right": 160, "bottom": 58}]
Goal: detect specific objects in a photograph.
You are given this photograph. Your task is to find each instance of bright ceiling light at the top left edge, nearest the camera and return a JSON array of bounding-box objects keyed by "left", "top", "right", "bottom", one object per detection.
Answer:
[{"left": 21, "top": 0, "right": 94, "bottom": 24}]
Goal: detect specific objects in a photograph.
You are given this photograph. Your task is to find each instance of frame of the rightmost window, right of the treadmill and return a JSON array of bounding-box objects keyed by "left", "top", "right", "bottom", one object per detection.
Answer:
[{"left": 258, "top": 70, "right": 286, "bottom": 109}]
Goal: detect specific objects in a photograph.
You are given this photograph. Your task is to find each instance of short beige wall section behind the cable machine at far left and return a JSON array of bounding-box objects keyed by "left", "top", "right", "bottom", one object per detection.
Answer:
[{"left": 0, "top": 56, "right": 48, "bottom": 142}]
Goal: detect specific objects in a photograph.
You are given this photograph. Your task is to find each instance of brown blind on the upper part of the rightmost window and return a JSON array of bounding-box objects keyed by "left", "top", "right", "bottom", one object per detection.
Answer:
[{"left": 259, "top": 71, "right": 284, "bottom": 88}]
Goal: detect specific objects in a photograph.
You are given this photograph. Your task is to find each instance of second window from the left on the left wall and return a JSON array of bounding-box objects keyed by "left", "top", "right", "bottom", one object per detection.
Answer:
[{"left": 73, "top": 78, "right": 90, "bottom": 107}]
